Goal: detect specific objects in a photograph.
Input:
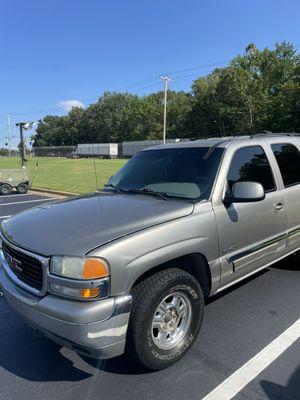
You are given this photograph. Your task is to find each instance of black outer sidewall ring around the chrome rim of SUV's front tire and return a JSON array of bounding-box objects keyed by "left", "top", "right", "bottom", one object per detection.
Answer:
[{"left": 140, "top": 277, "right": 204, "bottom": 369}]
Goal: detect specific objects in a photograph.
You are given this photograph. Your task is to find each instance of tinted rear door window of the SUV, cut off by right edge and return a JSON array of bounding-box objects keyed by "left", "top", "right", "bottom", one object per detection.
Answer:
[{"left": 271, "top": 143, "right": 300, "bottom": 187}]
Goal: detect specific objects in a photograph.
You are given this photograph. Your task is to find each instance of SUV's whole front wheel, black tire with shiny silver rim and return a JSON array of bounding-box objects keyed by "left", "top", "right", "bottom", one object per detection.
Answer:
[{"left": 127, "top": 268, "right": 204, "bottom": 370}]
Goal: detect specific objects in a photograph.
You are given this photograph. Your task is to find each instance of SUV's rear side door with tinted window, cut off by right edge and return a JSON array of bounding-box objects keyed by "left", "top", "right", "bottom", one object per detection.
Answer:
[{"left": 271, "top": 142, "right": 300, "bottom": 252}]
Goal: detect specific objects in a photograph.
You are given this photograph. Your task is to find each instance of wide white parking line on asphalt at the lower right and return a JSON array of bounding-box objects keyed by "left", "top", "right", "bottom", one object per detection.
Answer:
[{"left": 202, "top": 319, "right": 300, "bottom": 400}]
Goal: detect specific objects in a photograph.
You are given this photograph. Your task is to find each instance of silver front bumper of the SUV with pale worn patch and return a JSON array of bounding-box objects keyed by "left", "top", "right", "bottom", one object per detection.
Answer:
[{"left": 0, "top": 258, "right": 132, "bottom": 359}]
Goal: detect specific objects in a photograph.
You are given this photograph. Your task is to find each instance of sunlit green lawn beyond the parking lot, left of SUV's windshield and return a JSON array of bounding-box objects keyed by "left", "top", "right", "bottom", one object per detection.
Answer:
[{"left": 0, "top": 157, "right": 127, "bottom": 193}]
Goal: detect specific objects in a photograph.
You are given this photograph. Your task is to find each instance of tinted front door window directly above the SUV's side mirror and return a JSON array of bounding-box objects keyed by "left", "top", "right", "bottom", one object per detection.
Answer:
[{"left": 227, "top": 146, "right": 276, "bottom": 192}]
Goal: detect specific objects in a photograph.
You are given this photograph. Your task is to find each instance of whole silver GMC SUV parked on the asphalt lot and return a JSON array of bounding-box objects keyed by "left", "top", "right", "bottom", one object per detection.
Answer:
[{"left": 0, "top": 135, "right": 300, "bottom": 370}]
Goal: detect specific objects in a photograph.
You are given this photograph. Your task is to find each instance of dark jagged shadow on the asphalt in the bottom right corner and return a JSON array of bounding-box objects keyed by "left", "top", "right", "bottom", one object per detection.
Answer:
[{"left": 260, "top": 367, "right": 300, "bottom": 400}]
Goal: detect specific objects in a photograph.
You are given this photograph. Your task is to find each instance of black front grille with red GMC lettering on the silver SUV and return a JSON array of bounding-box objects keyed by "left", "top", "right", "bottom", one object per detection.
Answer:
[{"left": 2, "top": 242, "right": 43, "bottom": 290}]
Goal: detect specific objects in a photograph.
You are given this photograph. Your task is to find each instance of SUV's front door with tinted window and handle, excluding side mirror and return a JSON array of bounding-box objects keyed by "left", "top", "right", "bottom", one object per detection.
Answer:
[{"left": 213, "top": 143, "right": 286, "bottom": 286}]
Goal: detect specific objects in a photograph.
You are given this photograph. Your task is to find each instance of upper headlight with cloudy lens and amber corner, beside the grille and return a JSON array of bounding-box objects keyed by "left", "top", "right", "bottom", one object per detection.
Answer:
[{"left": 50, "top": 256, "right": 109, "bottom": 279}]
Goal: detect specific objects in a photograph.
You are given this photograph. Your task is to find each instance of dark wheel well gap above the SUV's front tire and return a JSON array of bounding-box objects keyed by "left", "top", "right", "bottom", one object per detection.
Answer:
[{"left": 133, "top": 253, "right": 211, "bottom": 298}]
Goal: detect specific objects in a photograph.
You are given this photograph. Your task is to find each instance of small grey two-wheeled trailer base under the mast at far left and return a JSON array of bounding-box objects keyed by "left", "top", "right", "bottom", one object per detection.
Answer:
[{"left": 0, "top": 168, "right": 29, "bottom": 194}]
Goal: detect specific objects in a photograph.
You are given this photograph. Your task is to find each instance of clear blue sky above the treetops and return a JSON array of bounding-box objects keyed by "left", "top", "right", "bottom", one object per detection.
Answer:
[{"left": 0, "top": 0, "right": 300, "bottom": 147}]
